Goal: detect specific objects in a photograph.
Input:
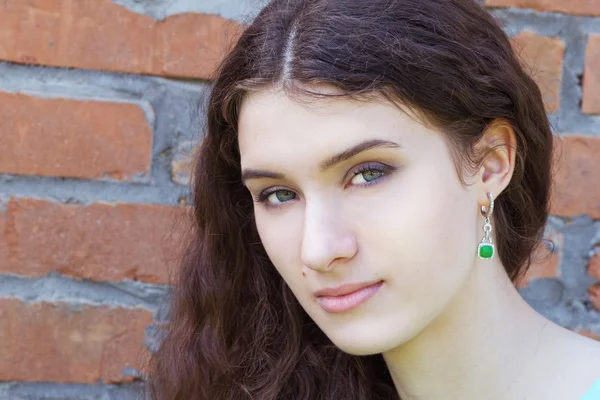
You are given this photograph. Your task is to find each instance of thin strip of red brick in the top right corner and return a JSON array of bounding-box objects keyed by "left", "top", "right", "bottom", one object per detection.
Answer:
[{"left": 485, "top": 0, "right": 600, "bottom": 16}]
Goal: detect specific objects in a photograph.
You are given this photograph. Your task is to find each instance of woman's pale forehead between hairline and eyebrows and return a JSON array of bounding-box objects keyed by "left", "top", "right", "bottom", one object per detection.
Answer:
[{"left": 238, "top": 89, "right": 426, "bottom": 166}]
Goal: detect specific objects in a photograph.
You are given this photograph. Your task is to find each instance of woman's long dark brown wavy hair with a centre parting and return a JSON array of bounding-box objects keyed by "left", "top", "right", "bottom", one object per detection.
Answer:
[{"left": 146, "top": 0, "right": 552, "bottom": 400}]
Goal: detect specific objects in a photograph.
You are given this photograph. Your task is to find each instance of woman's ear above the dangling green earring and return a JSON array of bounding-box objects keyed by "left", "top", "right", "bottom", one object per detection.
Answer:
[{"left": 476, "top": 119, "right": 517, "bottom": 206}]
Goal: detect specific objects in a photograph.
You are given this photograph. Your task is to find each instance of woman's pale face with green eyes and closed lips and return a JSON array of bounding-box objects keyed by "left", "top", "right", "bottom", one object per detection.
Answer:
[{"left": 239, "top": 90, "right": 481, "bottom": 355}]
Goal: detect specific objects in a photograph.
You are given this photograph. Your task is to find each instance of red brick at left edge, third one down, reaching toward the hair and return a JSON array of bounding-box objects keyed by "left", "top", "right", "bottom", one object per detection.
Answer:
[{"left": 0, "top": 198, "right": 181, "bottom": 283}]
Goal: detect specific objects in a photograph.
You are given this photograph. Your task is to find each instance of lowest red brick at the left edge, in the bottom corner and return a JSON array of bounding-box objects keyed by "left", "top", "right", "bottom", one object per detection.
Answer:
[{"left": 0, "top": 298, "right": 152, "bottom": 383}]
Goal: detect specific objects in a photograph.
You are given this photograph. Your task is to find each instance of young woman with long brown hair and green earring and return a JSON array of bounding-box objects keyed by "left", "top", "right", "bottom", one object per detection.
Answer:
[{"left": 148, "top": 0, "right": 600, "bottom": 400}]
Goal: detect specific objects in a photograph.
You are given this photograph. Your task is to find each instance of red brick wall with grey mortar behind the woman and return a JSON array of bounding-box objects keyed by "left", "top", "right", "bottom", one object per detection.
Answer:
[{"left": 0, "top": 0, "right": 600, "bottom": 399}]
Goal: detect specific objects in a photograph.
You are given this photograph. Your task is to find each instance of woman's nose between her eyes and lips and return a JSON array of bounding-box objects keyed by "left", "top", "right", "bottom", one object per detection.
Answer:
[{"left": 301, "top": 199, "right": 358, "bottom": 272}]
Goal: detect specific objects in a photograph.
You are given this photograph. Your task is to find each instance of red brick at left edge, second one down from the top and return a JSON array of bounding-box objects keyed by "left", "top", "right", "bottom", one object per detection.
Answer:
[{"left": 0, "top": 92, "right": 152, "bottom": 181}]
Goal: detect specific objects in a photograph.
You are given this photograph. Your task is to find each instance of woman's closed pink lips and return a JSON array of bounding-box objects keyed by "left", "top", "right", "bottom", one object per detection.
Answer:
[{"left": 315, "top": 281, "right": 383, "bottom": 313}]
